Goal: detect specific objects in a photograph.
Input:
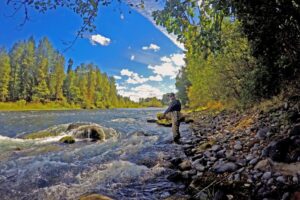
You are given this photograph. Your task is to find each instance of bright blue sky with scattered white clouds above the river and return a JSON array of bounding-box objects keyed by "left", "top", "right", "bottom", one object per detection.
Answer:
[{"left": 0, "top": 1, "right": 184, "bottom": 100}]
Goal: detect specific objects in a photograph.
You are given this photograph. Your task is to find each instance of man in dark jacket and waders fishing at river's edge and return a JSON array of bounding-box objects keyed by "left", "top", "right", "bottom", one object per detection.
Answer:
[{"left": 163, "top": 93, "right": 181, "bottom": 143}]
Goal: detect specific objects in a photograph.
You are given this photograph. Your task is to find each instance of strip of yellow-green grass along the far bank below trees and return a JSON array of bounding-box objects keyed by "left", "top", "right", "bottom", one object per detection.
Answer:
[{"left": 0, "top": 100, "right": 80, "bottom": 111}]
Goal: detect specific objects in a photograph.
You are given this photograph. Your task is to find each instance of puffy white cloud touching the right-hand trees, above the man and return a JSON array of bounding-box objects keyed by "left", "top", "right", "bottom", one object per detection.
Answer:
[{"left": 148, "top": 54, "right": 185, "bottom": 79}]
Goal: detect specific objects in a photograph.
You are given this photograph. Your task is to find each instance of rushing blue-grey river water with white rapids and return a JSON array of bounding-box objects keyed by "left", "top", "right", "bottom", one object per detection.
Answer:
[{"left": 0, "top": 108, "right": 190, "bottom": 200}]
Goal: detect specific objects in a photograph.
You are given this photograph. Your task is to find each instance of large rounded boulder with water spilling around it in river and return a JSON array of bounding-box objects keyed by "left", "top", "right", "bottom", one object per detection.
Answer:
[{"left": 68, "top": 123, "right": 118, "bottom": 140}]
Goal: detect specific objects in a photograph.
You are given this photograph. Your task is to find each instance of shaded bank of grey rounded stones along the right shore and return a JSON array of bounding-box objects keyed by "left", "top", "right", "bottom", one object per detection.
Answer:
[{"left": 167, "top": 96, "right": 300, "bottom": 200}]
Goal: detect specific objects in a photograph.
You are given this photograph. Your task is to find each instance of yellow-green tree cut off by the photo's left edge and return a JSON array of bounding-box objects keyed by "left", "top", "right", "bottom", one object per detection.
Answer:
[{"left": 0, "top": 49, "right": 11, "bottom": 101}]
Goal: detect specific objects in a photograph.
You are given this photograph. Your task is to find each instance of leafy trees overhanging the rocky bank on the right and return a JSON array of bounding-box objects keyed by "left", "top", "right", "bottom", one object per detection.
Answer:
[{"left": 153, "top": 0, "right": 300, "bottom": 108}]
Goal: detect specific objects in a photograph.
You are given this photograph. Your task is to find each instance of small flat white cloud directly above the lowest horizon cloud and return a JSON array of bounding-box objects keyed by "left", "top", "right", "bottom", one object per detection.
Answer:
[{"left": 120, "top": 69, "right": 163, "bottom": 84}]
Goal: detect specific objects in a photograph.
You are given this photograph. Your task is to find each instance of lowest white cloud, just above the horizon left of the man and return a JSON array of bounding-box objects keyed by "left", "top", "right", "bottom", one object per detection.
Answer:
[{"left": 118, "top": 84, "right": 163, "bottom": 102}]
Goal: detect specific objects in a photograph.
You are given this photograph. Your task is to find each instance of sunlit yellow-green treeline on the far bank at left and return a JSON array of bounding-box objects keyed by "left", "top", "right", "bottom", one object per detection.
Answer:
[{"left": 0, "top": 37, "right": 140, "bottom": 108}]
